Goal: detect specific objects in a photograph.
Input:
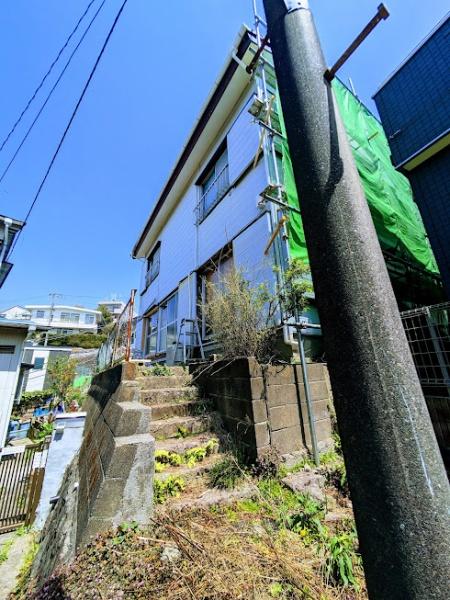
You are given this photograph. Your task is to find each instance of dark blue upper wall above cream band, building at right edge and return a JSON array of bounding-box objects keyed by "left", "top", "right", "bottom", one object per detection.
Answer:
[{"left": 374, "top": 18, "right": 450, "bottom": 166}]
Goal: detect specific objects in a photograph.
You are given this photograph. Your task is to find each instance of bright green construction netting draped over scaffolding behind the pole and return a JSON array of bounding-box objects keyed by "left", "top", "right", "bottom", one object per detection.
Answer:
[{"left": 278, "top": 80, "right": 439, "bottom": 273}]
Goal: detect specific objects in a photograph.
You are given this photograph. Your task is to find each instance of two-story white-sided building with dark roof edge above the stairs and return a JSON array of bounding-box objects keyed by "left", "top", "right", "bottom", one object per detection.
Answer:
[{"left": 132, "top": 27, "right": 442, "bottom": 363}]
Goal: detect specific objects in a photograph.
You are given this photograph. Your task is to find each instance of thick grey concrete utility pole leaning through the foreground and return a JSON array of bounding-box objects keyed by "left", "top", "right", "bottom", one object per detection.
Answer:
[{"left": 264, "top": 0, "right": 450, "bottom": 600}]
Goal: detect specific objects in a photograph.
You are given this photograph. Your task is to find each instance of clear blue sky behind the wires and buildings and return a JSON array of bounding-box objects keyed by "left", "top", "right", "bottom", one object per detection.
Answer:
[{"left": 0, "top": 0, "right": 448, "bottom": 308}]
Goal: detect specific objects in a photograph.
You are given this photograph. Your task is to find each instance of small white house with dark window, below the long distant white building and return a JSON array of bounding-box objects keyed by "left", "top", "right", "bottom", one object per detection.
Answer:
[{"left": 21, "top": 344, "right": 72, "bottom": 392}]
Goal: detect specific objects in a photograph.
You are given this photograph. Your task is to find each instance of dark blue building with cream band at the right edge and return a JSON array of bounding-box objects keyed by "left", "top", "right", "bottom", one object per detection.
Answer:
[{"left": 374, "top": 14, "right": 450, "bottom": 298}]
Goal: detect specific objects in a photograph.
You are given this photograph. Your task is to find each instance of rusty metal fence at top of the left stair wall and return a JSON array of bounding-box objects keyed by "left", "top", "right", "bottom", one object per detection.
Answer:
[{"left": 97, "top": 290, "right": 137, "bottom": 371}]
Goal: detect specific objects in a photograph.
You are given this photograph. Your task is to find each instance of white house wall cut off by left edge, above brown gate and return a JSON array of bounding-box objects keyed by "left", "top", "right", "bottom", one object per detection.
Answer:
[{"left": 0, "top": 319, "right": 35, "bottom": 447}]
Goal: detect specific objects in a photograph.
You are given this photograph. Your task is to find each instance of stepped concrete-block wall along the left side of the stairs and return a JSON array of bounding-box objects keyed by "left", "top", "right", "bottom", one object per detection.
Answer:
[{"left": 76, "top": 363, "right": 155, "bottom": 546}]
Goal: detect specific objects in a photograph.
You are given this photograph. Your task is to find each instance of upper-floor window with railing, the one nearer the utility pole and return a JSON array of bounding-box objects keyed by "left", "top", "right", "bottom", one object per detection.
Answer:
[{"left": 199, "top": 145, "right": 230, "bottom": 220}]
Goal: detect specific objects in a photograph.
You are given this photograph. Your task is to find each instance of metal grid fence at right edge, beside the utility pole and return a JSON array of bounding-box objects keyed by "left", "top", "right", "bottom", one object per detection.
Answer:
[{"left": 401, "top": 302, "right": 450, "bottom": 386}]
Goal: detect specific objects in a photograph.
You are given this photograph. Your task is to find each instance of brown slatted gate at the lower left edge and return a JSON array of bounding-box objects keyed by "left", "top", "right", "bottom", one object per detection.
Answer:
[{"left": 0, "top": 441, "right": 48, "bottom": 532}]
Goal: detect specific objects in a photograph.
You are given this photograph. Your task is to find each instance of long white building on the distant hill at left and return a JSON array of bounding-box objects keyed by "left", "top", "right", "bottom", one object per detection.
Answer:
[{"left": 25, "top": 304, "right": 101, "bottom": 335}]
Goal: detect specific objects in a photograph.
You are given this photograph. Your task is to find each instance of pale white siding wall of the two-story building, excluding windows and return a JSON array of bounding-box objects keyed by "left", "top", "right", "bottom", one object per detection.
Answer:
[{"left": 135, "top": 88, "right": 273, "bottom": 350}]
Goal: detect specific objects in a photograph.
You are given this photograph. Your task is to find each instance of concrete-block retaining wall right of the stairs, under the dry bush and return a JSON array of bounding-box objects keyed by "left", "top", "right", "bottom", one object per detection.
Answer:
[{"left": 197, "top": 358, "right": 332, "bottom": 459}]
